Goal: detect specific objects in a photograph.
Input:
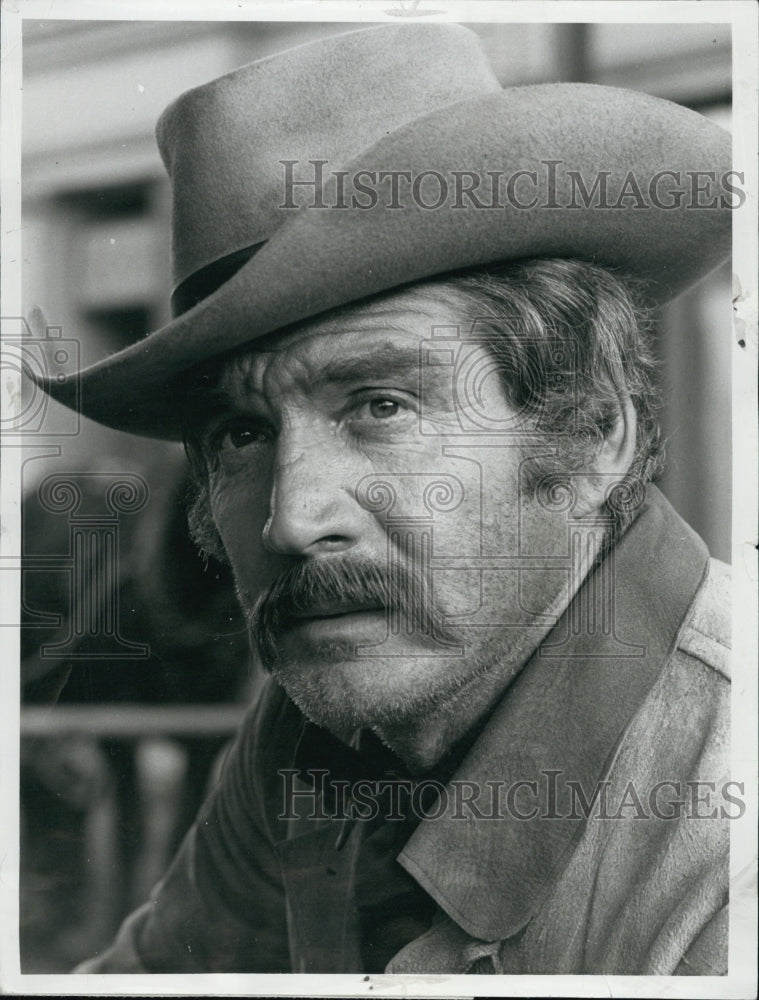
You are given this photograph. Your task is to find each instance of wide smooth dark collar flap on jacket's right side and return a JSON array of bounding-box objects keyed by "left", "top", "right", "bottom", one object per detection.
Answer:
[{"left": 398, "top": 486, "right": 708, "bottom": 941}]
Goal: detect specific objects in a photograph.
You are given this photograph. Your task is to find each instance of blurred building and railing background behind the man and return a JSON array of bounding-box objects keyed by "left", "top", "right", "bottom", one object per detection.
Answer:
[{"left": 16, "top": 20, "right": 731, "bottom": 973}]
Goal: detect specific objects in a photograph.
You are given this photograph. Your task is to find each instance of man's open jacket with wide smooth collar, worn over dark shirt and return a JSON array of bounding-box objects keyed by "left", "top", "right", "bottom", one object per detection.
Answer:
[{"left": 77, "top": 487, "right": 741, "bottom": 975}]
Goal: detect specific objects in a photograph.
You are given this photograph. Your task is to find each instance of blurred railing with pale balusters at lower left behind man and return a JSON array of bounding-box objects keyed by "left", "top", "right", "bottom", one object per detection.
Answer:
[{"left": 20, "top": 703, "right": 246, "bottom": 973}]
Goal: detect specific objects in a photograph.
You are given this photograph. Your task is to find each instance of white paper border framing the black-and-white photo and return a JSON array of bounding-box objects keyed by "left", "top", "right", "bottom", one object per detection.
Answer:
[{"left": 0, "top": 0, "right": 759, "bottom": 998}]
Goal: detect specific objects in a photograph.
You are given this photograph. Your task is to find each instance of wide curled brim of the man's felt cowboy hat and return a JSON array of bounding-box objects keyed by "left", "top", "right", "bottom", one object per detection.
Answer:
[{"left": 40, "top": 84, "right": 731, "bottom": 439}]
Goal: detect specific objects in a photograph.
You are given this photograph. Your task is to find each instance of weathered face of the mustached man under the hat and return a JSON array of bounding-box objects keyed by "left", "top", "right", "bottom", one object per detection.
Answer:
[{"left": 201, "top": 288, "right": 584, "bottom": 732}]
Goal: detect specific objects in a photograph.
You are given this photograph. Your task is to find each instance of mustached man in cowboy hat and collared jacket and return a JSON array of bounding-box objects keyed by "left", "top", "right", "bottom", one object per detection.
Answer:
[{"left": 38, "top": 25, "right": 739, "bottom": 975}]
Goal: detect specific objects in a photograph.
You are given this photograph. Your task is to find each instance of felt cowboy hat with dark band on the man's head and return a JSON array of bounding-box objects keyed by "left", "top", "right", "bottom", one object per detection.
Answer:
[{"left": 38, "top": 24, "right": 736, "bottom": 438}]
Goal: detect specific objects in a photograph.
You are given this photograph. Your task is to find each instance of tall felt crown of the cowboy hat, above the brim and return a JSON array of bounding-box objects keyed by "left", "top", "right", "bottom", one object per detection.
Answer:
[{"left": 156, "top": 24, "right": 500, "bottom": 285}]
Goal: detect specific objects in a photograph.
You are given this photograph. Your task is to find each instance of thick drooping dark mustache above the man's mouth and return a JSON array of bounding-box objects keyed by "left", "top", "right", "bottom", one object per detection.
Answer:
[{"left": 246, "top": 556, "right": 463, "bottom": 668}]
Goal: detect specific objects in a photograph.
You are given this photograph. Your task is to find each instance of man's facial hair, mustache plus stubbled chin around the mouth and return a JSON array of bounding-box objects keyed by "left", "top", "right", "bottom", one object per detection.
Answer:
[{"left": 233, "top": 559, "right": 516, "bottom": 733}]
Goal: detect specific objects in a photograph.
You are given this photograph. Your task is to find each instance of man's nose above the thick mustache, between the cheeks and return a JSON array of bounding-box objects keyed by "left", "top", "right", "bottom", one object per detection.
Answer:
[{"left": 262, "top": 433, "right": 361, "bottom": 556}]
